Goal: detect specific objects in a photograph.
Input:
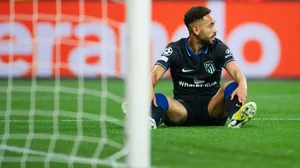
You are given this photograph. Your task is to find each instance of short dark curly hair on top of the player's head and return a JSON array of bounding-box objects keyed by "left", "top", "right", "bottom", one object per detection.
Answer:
[{"left": 184, "top": 6, "right": 211, "bottom": 28}]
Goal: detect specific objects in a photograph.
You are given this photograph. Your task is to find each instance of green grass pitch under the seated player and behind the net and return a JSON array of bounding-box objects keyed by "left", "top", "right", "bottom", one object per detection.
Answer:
[{"left": 0, "top": 80, "right": 300, "bottom": 168}]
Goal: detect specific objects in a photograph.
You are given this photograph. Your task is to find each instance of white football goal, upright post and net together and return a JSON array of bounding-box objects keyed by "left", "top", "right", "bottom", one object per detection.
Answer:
[{"left": 0, "top": 0, "right": 151, "bottom": 168}]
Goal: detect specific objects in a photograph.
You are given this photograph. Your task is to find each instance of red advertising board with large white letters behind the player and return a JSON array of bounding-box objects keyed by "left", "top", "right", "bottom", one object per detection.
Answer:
[{"left": 0, "top": 0, "right": 300, "bottom": 78}]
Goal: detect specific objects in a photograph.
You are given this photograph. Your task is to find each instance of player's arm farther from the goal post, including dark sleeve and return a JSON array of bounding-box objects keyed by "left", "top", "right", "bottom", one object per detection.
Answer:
[{"left": 217, "top": 43, "right": 247, "bottom": 105}]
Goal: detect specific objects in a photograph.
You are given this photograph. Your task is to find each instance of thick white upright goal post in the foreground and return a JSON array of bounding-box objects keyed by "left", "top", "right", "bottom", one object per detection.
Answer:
[{"left": 126, "top": 0, "right": 151, "bottom": 167}]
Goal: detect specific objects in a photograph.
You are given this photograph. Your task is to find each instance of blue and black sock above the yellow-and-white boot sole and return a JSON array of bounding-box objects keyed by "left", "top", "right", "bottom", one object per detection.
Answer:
[{"left": 224, "top": 82, "right": 242, "bottom": 119}]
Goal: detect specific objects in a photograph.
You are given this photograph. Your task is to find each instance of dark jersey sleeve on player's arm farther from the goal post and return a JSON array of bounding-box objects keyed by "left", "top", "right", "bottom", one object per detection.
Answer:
[{"left": 217, "top": 43, "right": 235, "bottom": 68}]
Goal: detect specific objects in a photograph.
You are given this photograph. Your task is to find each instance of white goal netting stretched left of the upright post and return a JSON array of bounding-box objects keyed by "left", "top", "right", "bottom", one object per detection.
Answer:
[{"left": 0, "top": 0, "right": 127, "bottom": 168}]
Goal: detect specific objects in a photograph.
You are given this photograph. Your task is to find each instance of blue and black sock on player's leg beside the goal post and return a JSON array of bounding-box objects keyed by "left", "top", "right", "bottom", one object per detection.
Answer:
[{"left": 151, "top": 93, "right": 169, "bottom": 126}]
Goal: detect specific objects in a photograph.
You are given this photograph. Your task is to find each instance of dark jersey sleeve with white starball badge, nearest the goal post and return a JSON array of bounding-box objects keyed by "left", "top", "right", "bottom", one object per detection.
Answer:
[{"left": 155, "top": 45, "right": 178, "bottom": 71}]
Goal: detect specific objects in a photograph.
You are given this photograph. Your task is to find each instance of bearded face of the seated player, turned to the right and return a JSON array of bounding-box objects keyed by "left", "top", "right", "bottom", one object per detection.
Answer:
[{"left": 194, "top": 14, "right": 217, "bottom": 45}]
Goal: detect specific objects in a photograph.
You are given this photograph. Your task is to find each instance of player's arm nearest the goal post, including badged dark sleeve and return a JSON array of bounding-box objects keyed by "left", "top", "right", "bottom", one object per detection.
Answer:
[{"left": 150, "top": 45, "right": 178, "bottom": 106}]
